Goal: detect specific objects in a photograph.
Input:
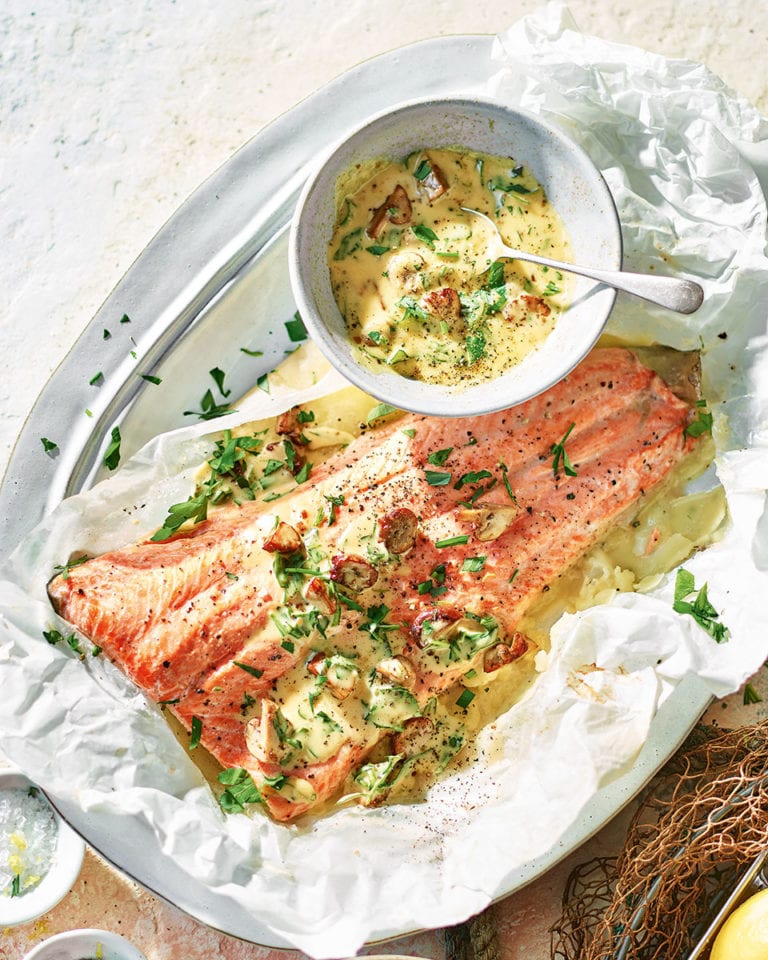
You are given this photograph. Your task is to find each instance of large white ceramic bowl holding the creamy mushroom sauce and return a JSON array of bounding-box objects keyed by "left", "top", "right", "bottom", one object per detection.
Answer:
[{"left": 289, "top": 97, "right": 622, "bottom": 416}]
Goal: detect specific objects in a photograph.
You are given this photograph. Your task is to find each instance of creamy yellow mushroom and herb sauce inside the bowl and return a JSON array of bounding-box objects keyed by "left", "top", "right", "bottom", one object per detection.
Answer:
[{"left": 328, "top": 150, "right": 572, "bottom": 386}]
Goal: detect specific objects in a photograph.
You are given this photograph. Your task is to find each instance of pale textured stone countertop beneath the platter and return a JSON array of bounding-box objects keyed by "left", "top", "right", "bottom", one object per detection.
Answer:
[{"left": 0, "top": 0, "right": 768, "bottom": 960}]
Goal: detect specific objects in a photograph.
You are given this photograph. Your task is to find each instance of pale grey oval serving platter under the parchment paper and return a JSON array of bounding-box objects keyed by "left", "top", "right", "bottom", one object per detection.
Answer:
[{"left": 0, "top": 37, "right": 709, "bottom": 948}]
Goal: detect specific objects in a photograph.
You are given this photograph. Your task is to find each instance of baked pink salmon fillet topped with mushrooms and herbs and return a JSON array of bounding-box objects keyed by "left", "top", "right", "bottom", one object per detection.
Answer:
[{"left": 49, "top": 348, "right": 696, "bottom": 820}]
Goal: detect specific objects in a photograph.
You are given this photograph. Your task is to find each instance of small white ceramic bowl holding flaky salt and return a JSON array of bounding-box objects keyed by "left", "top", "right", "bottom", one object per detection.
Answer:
[{"left": 0, "top": 769, "right": 85, "bottom": 927}]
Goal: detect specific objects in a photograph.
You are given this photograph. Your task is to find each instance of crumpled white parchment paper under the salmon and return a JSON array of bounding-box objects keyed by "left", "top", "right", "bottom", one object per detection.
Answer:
[{"left": 0, "top": 4, "right": 768, "bottom": 957}]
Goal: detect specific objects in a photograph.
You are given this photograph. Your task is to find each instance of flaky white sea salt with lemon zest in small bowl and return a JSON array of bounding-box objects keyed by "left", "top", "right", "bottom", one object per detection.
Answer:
[{"left": 0, "top": 787, "right": 58, "bottom": 897}]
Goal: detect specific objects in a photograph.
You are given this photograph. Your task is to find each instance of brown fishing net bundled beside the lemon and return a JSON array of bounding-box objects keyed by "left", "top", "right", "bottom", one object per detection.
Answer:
[{"left": 551, "top": 721, "right": 768, "bottom": 960}]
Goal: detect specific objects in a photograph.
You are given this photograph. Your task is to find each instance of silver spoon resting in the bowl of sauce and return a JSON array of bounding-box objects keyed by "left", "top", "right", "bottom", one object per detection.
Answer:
[{"left": 461, "top": 207, "right": 704, "bottom": 313}]
